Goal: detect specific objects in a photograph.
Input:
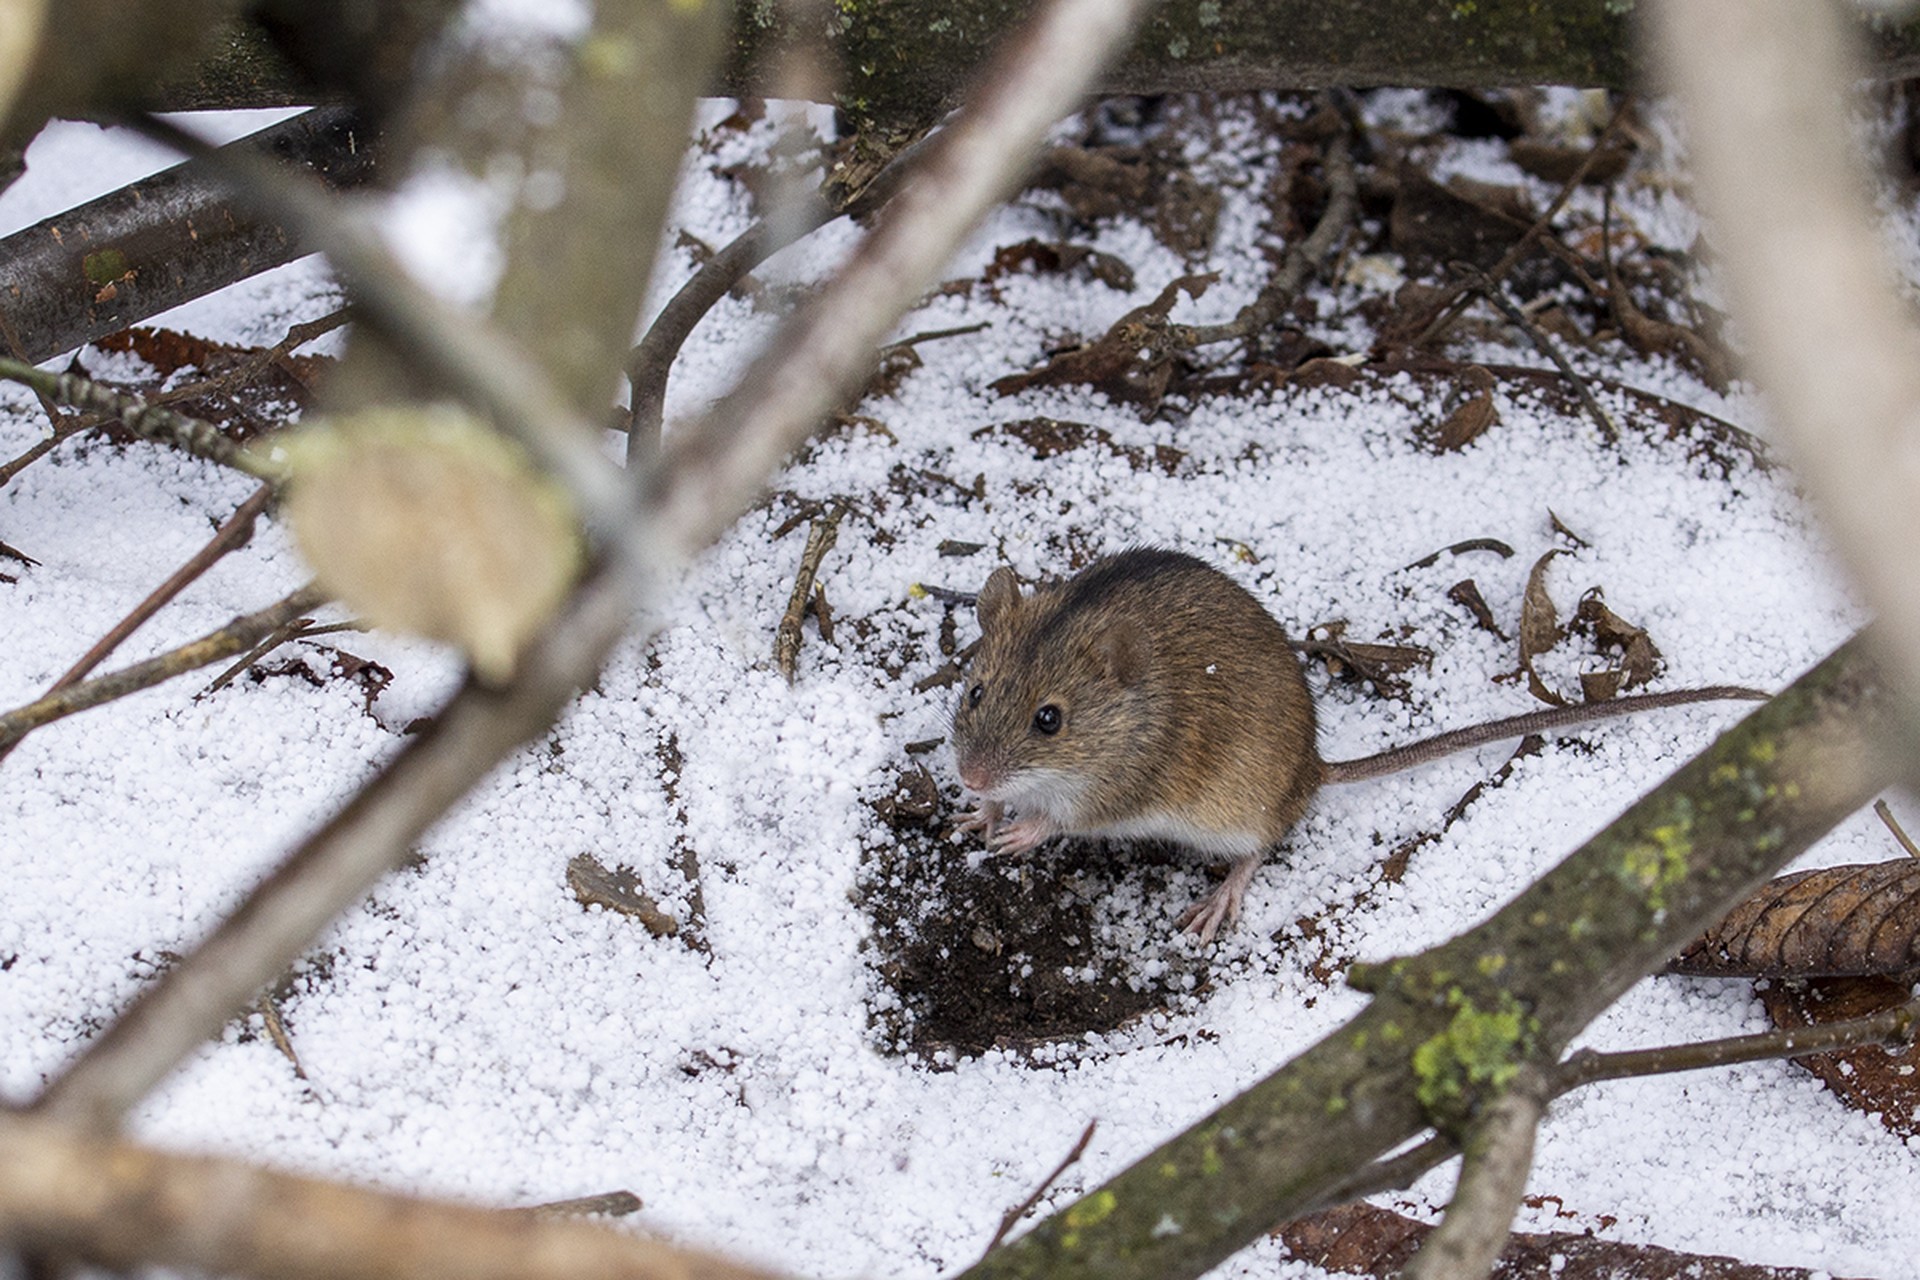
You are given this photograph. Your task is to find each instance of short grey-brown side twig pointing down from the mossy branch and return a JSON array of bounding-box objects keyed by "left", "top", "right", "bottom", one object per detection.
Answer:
[{"left": 1400, "top": 1065, "right": 1548, "bottom": 1280}]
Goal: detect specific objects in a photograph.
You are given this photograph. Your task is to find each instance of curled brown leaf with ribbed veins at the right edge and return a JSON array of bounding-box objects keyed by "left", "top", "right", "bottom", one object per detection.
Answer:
[{"left": 1668, "top": 858, "right": 1920, "bottom": 977}]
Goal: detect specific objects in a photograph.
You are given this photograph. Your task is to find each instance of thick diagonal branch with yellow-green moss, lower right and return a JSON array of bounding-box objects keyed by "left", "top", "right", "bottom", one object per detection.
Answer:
[{"left": 964, "top": 637, "right": 1901, "bottom": 1280}]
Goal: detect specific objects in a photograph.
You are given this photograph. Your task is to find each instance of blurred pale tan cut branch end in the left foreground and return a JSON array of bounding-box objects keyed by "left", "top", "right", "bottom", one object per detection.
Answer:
[{"left": 273, "top": 407, "right": 582, "bottom": 683}]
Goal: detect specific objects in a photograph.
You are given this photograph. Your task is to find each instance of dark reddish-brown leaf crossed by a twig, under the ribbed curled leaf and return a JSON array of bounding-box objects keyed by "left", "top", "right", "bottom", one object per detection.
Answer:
[{"left": 1761, "top": 977, "right": 1920, "bottom": 1138}]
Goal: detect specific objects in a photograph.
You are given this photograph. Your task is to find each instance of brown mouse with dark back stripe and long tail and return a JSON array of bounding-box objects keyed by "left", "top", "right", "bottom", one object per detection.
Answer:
[{"left": 952, "top": 547, "right": 1766, "bottom": 942}]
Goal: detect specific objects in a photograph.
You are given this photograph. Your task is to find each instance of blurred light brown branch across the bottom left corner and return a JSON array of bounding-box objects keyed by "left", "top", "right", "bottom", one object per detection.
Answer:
[{"left": 0, "top": 1113, "right": 787, "bottom": 1280}]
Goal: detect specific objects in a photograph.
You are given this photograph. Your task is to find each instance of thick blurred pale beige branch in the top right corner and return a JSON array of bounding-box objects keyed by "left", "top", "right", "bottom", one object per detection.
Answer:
[{"left": 1640, "top": 0, "right": 1920, "bottom": 721}]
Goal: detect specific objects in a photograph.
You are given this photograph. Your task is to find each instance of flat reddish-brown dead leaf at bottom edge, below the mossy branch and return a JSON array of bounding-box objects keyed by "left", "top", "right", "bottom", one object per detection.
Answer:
[{"left": 1275, "top": 1203, "right": 1850, "bottom": 1280}]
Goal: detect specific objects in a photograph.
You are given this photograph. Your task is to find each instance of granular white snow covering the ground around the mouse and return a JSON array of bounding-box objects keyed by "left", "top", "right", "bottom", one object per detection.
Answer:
[{"left": 0, "top": 94, "right": 1920, "bottom": 1278}]
